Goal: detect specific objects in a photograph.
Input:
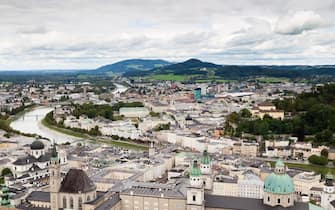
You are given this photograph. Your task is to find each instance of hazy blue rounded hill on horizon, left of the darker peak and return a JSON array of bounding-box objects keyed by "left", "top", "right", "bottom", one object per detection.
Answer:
[{"left": 96, "top": 59, "right": 171, "bottom": 73}]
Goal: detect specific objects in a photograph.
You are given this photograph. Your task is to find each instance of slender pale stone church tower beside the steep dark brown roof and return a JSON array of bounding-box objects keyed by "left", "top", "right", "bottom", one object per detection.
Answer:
[{"left": 49, "top": 144, "right": 61, "bottom": 210}]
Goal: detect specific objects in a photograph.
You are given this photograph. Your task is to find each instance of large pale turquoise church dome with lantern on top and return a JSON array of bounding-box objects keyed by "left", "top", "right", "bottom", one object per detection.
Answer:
[{"left": 264, "top": 160, "right": 294, "bottom": 194}]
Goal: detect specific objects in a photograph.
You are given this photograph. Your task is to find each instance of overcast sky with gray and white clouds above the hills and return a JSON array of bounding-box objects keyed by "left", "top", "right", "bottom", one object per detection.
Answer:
[{"left": 0, "top": 0, "right": 335, "bottom": 70}]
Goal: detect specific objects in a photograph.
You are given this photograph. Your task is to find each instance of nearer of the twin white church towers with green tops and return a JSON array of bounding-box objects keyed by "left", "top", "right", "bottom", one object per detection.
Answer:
[{"left": 187, "top": 160, "right": 205, "bottom": 210}]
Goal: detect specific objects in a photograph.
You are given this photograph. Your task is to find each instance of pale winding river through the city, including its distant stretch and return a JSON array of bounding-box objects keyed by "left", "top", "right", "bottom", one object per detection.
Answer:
[{"left": 10, "top": 83, "right": 128, "bottom": 143}]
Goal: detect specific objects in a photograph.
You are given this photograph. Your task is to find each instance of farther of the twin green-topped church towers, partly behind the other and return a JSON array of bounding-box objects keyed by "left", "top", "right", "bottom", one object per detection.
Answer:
[{"left": 200, "top": 150, "right": 213, "bottom": 190}]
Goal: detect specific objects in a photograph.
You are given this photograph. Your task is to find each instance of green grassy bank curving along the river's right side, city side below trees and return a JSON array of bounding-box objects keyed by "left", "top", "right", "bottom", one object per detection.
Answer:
[{"left": 41, "top": 110, "right": 149, "bottom": 150}]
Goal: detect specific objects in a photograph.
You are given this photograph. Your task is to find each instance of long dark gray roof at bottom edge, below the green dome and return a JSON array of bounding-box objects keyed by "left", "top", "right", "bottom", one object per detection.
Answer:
[{"left": 205, "top": 194, "right": 309, "bottom": 210}]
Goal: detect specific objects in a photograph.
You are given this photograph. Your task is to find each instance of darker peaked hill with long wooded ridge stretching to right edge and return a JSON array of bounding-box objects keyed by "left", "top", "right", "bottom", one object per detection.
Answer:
[{"left": 123, "top": 59, "right": 335, "bottom": 80}]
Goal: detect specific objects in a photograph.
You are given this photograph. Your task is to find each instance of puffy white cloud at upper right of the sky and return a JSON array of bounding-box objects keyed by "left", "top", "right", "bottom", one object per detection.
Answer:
[{"left": 274, "top": 11, "right": 330, "bottom": 35}]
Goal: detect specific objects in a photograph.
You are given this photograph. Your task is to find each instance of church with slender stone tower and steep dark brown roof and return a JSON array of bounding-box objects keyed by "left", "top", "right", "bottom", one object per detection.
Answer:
[{"left": 19, "top": 146, "right": 120, "bottom": 210}]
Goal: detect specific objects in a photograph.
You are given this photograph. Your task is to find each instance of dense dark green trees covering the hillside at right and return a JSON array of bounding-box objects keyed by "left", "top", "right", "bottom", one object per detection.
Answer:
[{"left": 225, "top": 84, "right": 335, "bottom": 146}]
